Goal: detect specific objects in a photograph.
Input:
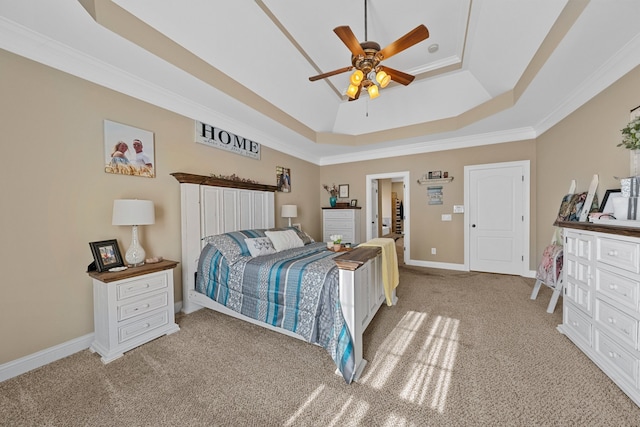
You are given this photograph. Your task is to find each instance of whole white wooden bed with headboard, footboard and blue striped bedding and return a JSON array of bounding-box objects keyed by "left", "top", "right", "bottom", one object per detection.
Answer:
[{"left": 172, "top": 173, "right": 397, "bottom": 383}]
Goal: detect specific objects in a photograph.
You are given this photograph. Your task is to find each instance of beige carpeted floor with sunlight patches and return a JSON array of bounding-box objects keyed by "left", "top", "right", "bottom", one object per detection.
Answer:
[{"left": 0, "top": 266, "right": 640, "bottom": 426}]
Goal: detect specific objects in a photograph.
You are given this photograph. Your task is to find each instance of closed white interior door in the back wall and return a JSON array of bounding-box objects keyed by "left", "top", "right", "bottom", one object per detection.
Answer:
[{"left": 465, "top": 161, "right": 529, "bottom": 275}]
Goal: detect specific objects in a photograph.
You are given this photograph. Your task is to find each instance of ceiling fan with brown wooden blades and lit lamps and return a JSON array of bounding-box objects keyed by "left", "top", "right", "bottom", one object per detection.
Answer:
[{"left": 309, "top": 0, "right": 429, "bottom": 101}]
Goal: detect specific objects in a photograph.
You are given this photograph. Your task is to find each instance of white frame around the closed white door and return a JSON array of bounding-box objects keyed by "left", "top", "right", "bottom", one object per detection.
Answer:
[{"left": 464, "top": 160, "right": 535, "bottom": 277}]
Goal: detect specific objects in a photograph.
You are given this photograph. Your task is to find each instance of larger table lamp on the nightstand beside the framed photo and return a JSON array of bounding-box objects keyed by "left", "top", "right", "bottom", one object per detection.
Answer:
[{"left": 112, "top": 199, "right": 156, "bottom": 267}]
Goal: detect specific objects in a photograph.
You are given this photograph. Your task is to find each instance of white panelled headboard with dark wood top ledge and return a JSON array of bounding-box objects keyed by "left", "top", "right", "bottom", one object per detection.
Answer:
[{"left": 171, "top": 172, "right": 277, "bottom": 313}]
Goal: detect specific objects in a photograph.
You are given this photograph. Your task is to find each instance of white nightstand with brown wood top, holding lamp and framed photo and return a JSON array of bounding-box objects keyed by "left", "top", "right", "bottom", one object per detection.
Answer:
[{"left": 89, "top": 260, "right": 180, "bottom": 363}]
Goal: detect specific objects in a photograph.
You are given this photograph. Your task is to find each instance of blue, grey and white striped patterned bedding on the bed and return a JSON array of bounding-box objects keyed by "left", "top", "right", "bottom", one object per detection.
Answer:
[{"left": 196, "top": 229, "right": 355, "bottom": 383}]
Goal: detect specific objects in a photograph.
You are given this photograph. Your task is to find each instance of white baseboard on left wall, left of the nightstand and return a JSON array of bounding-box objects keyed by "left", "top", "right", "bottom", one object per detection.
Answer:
[{"left": 0, "top": 333, "right": 93, "bottom": 382}]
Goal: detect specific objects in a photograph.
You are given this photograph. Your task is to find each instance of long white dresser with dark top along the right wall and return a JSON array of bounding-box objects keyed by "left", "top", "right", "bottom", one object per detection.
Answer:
[{"left": 558, "top": 223, "right": 640, "bottom": 406}]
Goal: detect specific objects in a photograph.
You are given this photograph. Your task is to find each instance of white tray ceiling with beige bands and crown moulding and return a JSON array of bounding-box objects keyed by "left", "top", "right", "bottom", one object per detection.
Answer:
[{"left": 0, "top": 0, "right": 640, "bottom": 164}]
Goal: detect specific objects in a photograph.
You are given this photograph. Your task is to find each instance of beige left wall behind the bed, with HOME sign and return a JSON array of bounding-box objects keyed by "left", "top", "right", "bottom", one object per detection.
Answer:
[{"left": 0, "top": 50, "right": 321, "bottom": 364}]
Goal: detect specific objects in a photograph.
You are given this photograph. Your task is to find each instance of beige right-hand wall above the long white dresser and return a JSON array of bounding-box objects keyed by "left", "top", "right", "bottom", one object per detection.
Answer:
[{"left": 536, "top": 67, "right": 640, "bottom": 252}]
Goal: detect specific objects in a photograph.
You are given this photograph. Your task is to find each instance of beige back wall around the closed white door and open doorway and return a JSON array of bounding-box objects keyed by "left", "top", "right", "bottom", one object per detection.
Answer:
[{"left": 320, "top": 141, "right": 535, "bottom": 264}]
